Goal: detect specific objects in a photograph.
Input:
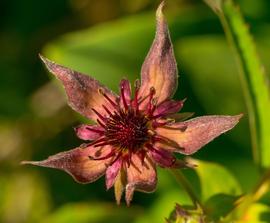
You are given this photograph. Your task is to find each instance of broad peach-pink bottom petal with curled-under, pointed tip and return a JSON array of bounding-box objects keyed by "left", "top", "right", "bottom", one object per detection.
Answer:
[{"left": 126, "top": 155, "right": 157, "bottom": 205}]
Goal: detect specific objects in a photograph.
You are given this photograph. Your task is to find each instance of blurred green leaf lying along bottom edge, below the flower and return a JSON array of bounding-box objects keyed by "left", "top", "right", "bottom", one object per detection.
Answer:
[{"left": 40, "top": 203, "right": 142, "bottom": 223}]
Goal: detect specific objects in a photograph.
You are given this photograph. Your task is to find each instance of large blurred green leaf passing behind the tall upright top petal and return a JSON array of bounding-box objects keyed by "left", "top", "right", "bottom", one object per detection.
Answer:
[{"left": 43, "top": 8, "right": 218, "bottom": 91}]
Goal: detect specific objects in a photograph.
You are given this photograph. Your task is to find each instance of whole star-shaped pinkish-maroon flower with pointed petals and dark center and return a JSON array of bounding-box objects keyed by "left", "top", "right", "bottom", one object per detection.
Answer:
[{"left": 23, "top": 3, "right": 241, "bottom": 205}]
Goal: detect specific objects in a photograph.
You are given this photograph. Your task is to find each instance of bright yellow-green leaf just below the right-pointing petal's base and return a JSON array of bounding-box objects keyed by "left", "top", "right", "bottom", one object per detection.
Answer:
[{"left": 191, "top": 160, "right": 241, "bottom": 201}]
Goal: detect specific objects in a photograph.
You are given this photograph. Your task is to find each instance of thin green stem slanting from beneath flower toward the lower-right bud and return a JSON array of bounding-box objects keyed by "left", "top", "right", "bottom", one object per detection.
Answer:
[{"left": 170, "top": 169, "right": 204, "bottom": 210}]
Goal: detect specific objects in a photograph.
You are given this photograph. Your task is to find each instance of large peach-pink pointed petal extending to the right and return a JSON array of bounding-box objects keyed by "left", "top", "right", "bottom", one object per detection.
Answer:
[{"left": 156, "top": 115, "right": 242, "bottom": 155}]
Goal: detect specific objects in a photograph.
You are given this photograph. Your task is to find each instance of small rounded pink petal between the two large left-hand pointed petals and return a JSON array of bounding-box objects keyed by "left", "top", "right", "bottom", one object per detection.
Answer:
[{"left": 74, "top": 125, "right": 104, "bottom": 140}]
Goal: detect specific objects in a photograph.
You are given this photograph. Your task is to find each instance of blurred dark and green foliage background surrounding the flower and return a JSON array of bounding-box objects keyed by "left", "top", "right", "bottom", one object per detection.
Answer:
[{"left": 0, "top": 0, "right": 270, "bottom": 223}]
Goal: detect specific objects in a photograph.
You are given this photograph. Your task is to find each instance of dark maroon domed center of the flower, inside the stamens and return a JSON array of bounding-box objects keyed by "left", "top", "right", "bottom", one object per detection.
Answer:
[{"left": 105, "top": 109, "right": 149, "bottom": 151}]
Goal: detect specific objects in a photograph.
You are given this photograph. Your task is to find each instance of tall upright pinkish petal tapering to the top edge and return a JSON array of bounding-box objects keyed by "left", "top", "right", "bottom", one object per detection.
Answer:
[{"left": 139, "top": 2, "right": 178, "bottom": 103}]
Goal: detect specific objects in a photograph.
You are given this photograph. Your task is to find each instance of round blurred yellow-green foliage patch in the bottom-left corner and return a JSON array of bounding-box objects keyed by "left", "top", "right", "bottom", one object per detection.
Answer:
[{"left": 0, "top": 172, "right": 50, "bottom": 223}]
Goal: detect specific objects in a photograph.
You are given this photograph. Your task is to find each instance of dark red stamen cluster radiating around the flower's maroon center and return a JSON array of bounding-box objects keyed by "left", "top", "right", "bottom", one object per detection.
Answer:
[{"left": 88, "top": 80, "right": 163, "bottom": 165}]
